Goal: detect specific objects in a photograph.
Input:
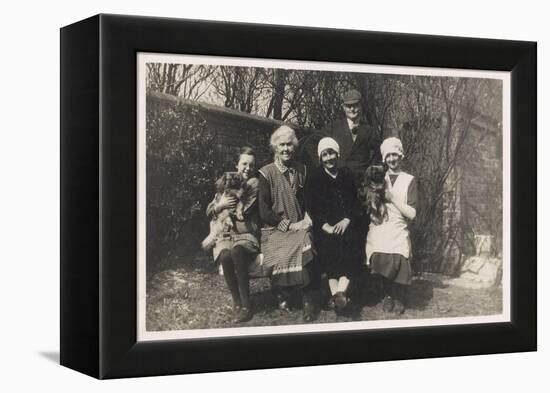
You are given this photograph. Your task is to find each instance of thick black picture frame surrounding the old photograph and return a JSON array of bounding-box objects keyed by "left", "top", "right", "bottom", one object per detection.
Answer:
[{"left": 60, "top": 15, "right": 537, "bottom": 379}]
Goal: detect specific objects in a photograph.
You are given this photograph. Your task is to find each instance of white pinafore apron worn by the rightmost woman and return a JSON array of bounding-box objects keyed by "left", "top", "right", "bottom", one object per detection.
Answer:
[{"left": 366, "top": 172, "right": 413, "bottom": 265}]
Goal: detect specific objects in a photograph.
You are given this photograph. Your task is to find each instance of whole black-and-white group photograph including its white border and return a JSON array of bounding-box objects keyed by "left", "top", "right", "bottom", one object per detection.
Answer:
[{"left": 137, "top": 53, "right": 510, "bottom": 340}]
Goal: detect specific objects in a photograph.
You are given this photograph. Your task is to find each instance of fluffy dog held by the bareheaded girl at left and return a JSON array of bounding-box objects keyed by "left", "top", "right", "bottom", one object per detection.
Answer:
[{"left": 202, "top": 172, "right": 252, "bottom": 250}]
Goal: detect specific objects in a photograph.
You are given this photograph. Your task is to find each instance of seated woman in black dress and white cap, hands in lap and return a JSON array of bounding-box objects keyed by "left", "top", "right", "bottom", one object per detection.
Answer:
[{"left": 306, "top": 138, "right": 364, "bottom": 314}]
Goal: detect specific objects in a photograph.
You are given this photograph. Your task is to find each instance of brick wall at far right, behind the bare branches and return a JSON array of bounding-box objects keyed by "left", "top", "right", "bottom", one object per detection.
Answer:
[{"left": 442, "top": 115, "right": 503, "bottom": 274}]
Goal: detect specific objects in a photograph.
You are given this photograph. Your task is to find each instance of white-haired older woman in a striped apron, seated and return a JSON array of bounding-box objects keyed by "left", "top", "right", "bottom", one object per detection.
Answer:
[{"left": 258, "top": 126, "right": 320, "bottom": 322}]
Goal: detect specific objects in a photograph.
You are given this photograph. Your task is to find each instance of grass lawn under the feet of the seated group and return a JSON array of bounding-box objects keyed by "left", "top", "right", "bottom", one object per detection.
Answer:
[{"left": 146, "top": 268, "right": 502, "bottom": 331}]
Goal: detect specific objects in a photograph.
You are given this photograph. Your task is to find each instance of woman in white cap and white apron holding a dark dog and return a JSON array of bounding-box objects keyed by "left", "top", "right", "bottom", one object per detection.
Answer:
[{"left": 366, "top": 137, "right": 417, "bottom": 314}]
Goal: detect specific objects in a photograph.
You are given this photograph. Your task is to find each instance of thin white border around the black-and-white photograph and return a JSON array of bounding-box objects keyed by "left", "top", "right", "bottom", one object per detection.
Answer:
[{"left": 137, "top": 53, "right": 511, "bottom": 341}]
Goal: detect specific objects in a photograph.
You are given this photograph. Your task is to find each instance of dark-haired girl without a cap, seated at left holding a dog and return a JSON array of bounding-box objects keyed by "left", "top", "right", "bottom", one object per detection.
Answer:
[{"left": 206, "top": 147, "right": 260, "bottom": 322}]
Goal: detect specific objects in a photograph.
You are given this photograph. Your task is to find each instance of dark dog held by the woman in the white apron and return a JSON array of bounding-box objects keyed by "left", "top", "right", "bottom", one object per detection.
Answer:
[{"left": 361, "top": 165, "right": 388, "bottom": 225}]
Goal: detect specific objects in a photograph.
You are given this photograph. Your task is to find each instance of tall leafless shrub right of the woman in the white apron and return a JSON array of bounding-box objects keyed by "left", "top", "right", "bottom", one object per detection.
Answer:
[{"left": 399, "top": 76, "right": 498, "bottom": 271}]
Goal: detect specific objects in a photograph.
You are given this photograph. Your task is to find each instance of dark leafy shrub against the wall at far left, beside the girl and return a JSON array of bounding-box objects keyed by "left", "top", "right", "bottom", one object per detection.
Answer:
[{"left": 146, "top": 104, "right": 219, "bottom": 271}]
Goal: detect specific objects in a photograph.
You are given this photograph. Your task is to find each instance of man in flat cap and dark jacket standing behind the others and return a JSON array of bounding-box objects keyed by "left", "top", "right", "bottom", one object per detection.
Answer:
[{"left": 322, "top": 89, "right": 382, "bottom": 187}]
